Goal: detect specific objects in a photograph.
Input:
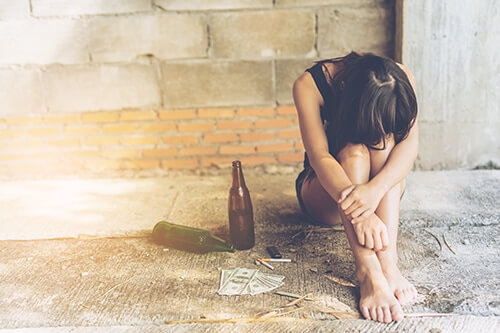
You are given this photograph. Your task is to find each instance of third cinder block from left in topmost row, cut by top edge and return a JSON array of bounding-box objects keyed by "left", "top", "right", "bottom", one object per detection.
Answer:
[{"left": 154, "top": 0, "right": 273, "bottom": 10}]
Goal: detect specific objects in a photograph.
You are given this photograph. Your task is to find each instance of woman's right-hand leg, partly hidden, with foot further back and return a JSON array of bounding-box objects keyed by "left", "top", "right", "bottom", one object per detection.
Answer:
[{"left": 370, "top": 137, "right": 417, "bottom": 304}]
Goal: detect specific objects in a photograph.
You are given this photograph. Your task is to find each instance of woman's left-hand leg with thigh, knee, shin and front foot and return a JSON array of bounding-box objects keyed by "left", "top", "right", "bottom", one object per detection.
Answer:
[{"left": 301, "top": 144, "right": 403, "bottom": 322}]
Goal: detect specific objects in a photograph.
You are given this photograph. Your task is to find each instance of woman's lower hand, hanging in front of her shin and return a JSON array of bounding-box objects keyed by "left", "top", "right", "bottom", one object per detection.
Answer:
[{"left": 353, "top": 214, "right": 389, "bottom": 251}]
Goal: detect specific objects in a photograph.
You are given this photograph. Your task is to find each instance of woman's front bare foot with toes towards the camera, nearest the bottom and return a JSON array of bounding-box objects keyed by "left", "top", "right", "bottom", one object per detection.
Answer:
[{"left": 357, "top": 264, "right": 404, "bottom": 323}]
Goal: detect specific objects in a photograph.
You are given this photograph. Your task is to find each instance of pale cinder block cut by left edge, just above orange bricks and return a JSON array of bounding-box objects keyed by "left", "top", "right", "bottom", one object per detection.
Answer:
[{"left": 0, "top": 68, "right": 45, "bottom": 116}]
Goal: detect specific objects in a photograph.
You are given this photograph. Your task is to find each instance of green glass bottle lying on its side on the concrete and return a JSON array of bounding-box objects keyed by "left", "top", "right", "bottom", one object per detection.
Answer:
[{"left": 153, "top": 221, "right": 236, "bottom": 253}]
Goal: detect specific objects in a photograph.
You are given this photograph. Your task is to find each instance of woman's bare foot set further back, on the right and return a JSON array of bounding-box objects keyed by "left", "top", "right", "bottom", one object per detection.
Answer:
[{"left": 379, "top": 253, "right": 417, "bottom": 305}]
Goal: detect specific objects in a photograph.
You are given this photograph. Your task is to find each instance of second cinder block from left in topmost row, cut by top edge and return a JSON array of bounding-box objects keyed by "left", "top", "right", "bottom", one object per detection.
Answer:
[{"left": 31, "top": 0, "right": 151, "bottom": 16}]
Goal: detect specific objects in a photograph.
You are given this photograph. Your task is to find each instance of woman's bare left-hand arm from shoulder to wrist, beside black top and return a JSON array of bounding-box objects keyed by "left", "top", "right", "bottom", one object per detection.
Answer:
[{"left": 293, "top": 72, "right": 352, "bottom": 202}]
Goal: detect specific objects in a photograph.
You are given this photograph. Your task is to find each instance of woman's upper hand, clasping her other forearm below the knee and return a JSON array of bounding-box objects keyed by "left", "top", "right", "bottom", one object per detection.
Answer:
[{"left": 338, "top": 183, "right": 384, "bottom": 223}]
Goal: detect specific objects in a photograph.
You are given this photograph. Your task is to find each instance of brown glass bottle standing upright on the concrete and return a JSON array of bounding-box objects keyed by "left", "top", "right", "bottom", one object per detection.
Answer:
[{"left": 228, "top": 161, "right": 255, "bottom": 250}]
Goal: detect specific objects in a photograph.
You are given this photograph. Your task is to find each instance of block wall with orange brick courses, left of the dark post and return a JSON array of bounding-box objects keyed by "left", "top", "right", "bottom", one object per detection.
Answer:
[{"left": 0, "top": 0, "right": 394, "bottom": 175}]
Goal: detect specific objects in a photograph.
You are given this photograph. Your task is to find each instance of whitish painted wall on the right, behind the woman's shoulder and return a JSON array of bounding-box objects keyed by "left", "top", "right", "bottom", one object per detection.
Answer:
[{"left": 401, "top": 0, "right": 500, "bottom": 169}]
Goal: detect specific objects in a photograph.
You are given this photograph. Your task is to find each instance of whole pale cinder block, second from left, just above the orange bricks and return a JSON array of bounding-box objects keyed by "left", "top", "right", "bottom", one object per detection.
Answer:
[{"left": 42, "top": 64, "right": 161, "bottom": 112}]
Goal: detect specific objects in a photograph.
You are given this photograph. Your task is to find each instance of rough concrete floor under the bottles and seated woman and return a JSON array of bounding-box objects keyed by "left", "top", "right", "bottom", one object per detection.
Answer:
[{"left": 0, "top": 169, "right": 500, "bottom": 332}]
